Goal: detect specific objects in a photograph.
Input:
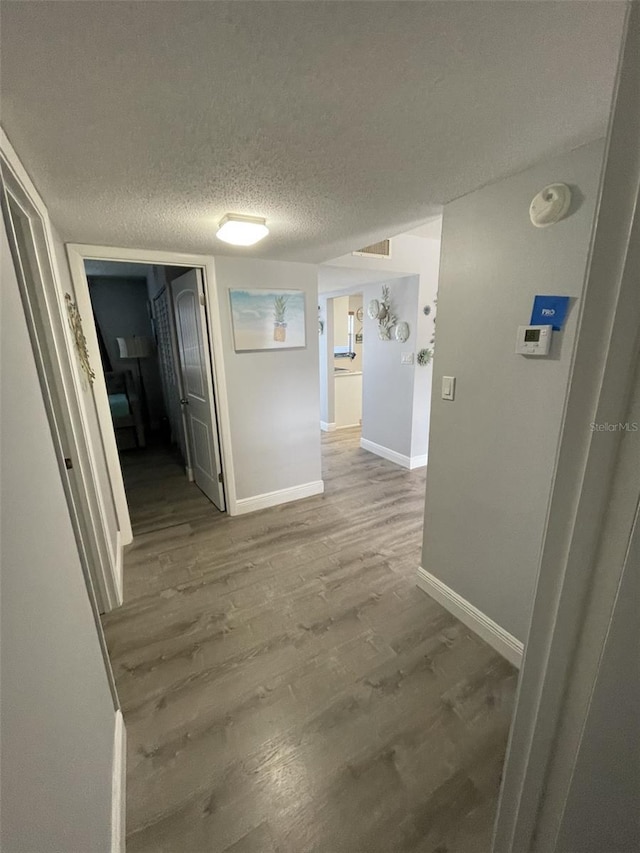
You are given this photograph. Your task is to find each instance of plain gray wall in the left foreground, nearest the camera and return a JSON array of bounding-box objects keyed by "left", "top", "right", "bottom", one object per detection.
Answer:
[{"left": 0, "top": 221, "right": 115, "bottom": 853}]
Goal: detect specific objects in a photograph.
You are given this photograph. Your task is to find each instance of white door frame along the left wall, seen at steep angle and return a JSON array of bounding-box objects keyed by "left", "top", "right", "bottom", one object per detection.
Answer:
[{"left": 0, "top": 128, "right": 122, "bottom": 711}]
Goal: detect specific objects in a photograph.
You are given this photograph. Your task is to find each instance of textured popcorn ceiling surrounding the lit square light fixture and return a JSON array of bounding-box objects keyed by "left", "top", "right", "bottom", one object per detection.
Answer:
[{"left": 0, "top": 0, "right": 624, "bottom": 261}]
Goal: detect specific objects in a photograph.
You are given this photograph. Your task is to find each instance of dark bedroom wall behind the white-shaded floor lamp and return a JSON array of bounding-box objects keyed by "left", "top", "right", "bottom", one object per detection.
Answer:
[{"left": 88, "top": 276, "right": 166, "bottom": 429}]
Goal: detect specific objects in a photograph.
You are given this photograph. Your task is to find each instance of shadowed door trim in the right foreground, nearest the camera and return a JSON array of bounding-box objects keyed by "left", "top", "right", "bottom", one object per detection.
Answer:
[{"left": 492, "top": 8, "right": 640, "bottom": 853}]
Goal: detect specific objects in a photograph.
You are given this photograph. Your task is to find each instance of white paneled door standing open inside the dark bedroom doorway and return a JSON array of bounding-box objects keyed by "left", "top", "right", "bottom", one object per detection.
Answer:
[{"left": 171, "top": 270, "right": 225, "bottom": 510}]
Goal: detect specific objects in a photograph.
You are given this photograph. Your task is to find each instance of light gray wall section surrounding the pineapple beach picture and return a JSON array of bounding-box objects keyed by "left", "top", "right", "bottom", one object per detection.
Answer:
[{"left": 215, "top": 257, "right": 322, "bottom": 499}]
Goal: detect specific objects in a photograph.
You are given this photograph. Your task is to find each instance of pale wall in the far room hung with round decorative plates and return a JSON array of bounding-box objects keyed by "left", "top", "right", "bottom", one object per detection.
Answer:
[{"left": 362, "top": 275, "right": 419, "bottom": 456}]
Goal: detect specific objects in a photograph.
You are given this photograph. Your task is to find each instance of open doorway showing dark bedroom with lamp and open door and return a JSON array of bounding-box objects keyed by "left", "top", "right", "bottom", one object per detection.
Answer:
[{"left": 84, "top": 260, "right": 226, "bottom": 536}]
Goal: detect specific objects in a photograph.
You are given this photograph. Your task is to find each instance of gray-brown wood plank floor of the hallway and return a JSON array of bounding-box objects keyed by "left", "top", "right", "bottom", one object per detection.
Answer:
[{"left": 104, "top": 430, "right": 516, "bottom": 853}]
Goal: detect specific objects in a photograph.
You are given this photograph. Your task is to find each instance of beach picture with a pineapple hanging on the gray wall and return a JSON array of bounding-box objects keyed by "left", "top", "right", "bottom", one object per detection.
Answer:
[{"left": 229, "top": 289, "right": 307, "bottom": 352}]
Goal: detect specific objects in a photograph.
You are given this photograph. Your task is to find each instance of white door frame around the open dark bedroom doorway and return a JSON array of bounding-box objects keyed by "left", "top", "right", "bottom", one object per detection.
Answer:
[{"left": 65, "top": 243, "right": 237, "bottom": 527}]
